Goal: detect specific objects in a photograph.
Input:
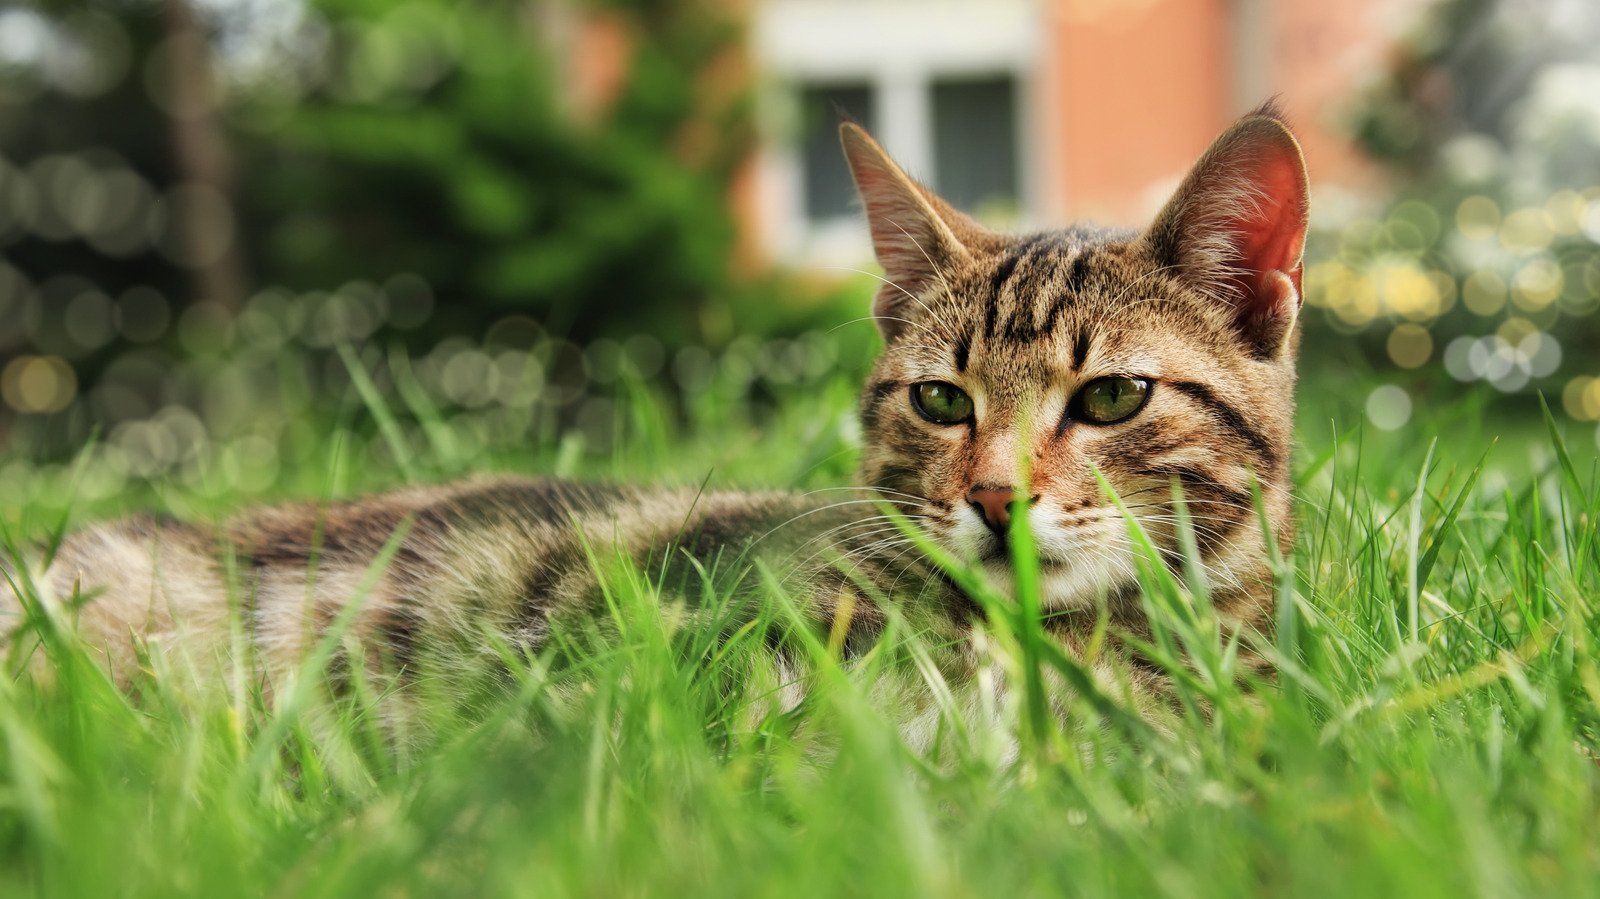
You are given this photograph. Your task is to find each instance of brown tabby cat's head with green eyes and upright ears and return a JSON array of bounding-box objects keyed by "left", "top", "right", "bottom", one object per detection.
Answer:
[{"left": 842, "top": 103, "right": 1309, "bottom": 609}]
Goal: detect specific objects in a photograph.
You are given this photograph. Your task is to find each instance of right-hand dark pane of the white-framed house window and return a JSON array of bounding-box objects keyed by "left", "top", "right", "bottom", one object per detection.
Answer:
[{"left": 933, "top": 77, "right": 1018, "bottom": 210}]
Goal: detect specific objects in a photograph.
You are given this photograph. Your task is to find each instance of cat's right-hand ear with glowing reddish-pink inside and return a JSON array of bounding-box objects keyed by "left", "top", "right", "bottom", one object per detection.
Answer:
[{"left": 1144, "top": 106, "right": 1310, "bottom": 358}]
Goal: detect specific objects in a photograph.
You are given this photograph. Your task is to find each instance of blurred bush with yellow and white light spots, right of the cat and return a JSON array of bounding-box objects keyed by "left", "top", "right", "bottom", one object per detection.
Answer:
[{"left": 1306, "top": 0, "right": 1600, "bottom": 421}]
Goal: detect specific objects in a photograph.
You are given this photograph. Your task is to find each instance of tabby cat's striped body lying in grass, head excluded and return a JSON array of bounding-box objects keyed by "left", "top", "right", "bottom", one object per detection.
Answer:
[{"left": 15, "top": 477, "right": 928, "bottom": 697}]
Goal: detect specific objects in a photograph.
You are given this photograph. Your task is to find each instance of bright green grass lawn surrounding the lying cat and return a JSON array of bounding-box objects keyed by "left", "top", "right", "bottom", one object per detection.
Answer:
[{"left": 0, "top": 348, "right": 1600, "bottom": 897}]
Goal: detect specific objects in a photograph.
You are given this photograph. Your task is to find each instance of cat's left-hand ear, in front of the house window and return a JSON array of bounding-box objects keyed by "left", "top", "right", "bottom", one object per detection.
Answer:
[{"left": 838, "top": 122, "right": 981, "bottom": 341}]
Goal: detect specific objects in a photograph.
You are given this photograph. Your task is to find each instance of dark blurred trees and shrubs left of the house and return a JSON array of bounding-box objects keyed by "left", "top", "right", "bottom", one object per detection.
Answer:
[{"left": 0, "top": 0, "right": 870, "bottom": 457}]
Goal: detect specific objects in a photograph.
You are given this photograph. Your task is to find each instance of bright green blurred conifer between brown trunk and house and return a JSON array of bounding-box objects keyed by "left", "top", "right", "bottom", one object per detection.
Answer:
[{"left": 240, "top": 0, "right": 752, "bottom": 344}]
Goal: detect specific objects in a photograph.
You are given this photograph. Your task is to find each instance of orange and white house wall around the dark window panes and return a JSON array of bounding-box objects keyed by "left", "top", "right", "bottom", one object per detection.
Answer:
[{"left": 739, "top": 0, "right": 1432, "bottom": 264}]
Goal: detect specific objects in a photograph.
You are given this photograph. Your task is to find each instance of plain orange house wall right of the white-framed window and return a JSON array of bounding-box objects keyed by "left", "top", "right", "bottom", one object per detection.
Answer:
[{"left": 1034, "top": 0, "right": 1429, "bottom": 224}]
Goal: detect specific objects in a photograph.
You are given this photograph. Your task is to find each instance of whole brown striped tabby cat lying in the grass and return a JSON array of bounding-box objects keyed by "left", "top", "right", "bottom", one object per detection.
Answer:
[{"left": 0, "top": 109, "right": 1307, "bottom": 719}]
